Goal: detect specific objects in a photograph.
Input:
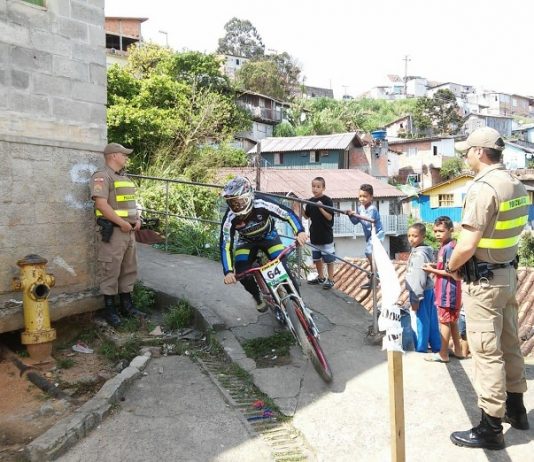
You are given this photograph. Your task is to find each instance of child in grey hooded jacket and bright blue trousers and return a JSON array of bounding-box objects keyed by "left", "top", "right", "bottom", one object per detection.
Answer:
[{"left": 406, "top": 223, "right": 445, "bottom": 354}]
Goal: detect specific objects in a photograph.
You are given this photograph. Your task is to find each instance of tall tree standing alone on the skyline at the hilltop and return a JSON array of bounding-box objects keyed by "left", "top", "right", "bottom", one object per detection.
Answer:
[{"left": 217, "top": 17, "right": 265, "bottom": 58}]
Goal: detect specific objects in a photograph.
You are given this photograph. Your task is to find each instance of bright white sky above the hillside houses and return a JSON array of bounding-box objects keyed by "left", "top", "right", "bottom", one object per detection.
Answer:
[{"left": 106, "top": 0, "right": 534, "bottom": 97}]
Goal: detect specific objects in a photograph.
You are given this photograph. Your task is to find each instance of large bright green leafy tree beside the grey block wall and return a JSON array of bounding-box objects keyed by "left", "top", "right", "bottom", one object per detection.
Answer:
[{"left": 108, "top": 45, "right": 250, "bottom": 173}]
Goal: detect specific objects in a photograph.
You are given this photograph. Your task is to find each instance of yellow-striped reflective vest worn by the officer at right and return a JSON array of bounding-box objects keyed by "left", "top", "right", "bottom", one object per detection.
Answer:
[{"left": 475, "top": 168, "right": 530, "bottom": 263}]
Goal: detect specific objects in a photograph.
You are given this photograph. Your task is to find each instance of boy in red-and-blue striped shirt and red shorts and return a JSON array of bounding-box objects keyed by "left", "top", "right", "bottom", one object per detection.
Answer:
[{"left": 423, "top": 216, "right": 463, "bottom": 363}]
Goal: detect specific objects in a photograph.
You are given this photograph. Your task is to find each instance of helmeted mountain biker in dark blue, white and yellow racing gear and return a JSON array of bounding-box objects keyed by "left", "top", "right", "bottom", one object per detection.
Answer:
[{"left": 219, "top": 176, "right": 308, "bottom": 313}]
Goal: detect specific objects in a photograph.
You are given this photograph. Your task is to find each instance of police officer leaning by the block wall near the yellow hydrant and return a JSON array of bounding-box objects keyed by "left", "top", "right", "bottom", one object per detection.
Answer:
[{"left": 91, "top": 143, "right": 142, "bottom": 327}]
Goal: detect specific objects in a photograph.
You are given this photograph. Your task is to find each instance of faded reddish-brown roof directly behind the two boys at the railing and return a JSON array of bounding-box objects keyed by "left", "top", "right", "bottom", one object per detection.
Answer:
[{"left": 219, "top": 167, "right": 404, "bottom": 199}]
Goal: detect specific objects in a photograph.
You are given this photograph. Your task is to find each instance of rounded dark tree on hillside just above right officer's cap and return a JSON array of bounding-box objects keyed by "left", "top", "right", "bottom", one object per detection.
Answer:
[{"left": 414, "top": 90, "right": 462, "bottom": 135}]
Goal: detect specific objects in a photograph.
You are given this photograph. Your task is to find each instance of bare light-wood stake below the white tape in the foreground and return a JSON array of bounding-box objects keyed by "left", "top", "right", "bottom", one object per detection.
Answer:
[{"left": 388, "top": 351, "right": 406, "bottom": 462}]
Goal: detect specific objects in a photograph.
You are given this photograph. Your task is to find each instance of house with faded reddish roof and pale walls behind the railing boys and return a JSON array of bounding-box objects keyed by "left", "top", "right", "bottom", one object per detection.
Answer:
[{"left": 219, "top": 167, "right": 408, "bottom": 257}]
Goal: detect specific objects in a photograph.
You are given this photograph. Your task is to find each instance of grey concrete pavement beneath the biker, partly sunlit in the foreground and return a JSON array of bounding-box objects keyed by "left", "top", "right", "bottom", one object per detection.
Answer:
[{"left": 60, "top": 245, "right": 534, "bottom": 462}]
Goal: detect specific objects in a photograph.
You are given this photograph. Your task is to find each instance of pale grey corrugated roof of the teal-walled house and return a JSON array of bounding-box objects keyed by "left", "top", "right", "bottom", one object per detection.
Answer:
[{"left": 248, "top": 132, "right": 363, "bottom": 154}]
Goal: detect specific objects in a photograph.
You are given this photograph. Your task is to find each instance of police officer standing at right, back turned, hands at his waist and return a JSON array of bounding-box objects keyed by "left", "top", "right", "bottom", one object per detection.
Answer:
[{"left": 446, "top": 127, "right": 529, "bottom": 449}]
